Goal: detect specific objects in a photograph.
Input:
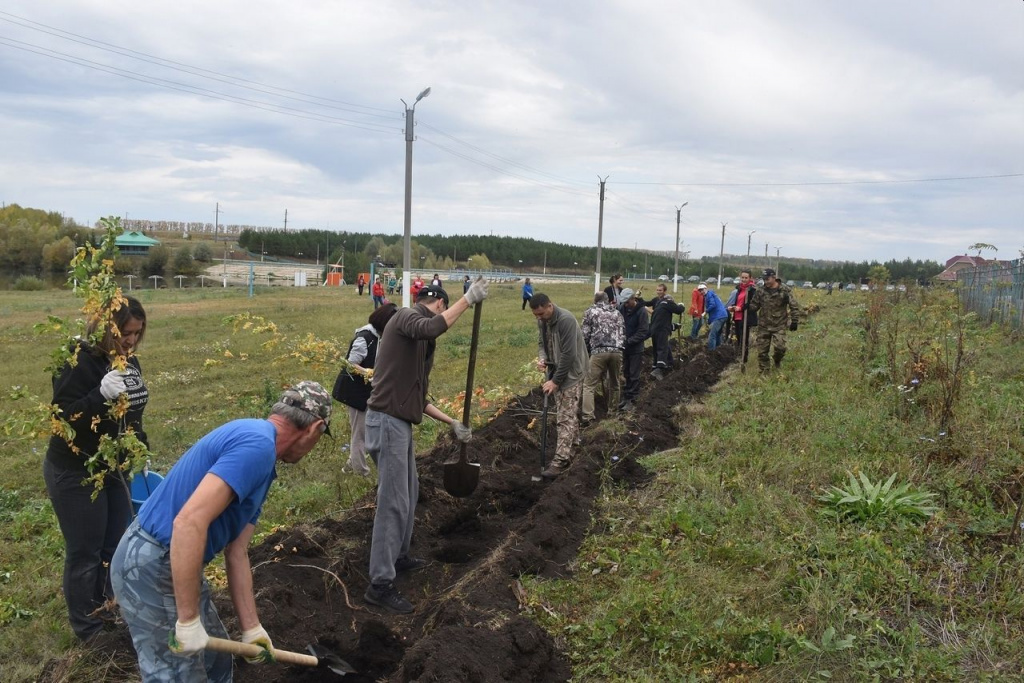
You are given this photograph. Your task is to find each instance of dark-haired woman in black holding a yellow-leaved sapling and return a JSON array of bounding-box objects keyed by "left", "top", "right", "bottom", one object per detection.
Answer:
[{"left": 43, "top": 296, "right": 150, "bottom": 643}]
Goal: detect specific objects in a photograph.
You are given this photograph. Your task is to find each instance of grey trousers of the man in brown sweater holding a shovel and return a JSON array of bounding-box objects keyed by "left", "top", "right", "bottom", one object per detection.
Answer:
[{"left": 367, "top": 409, "right": 420, "bottom": 584}]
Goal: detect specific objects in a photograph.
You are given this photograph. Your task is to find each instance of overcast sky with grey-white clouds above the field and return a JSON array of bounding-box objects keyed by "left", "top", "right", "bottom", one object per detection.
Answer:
[{"left": 0, "top": 0, "right": 1024, "bottom": 261}]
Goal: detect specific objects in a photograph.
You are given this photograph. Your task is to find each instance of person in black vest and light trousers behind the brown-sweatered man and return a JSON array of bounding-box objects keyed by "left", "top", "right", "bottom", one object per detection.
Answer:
[{"left": 331, "top": 302, "right": 398, "bottom": 476}]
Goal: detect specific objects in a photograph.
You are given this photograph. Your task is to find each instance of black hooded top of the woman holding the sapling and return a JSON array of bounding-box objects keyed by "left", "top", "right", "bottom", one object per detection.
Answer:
[{"left": 46, "top": 344, "right": 150, "bottom": 473}]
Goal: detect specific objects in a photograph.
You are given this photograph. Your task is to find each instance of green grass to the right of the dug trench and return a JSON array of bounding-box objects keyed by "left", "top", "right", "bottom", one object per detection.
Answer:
[{"left": 528, "top": 295, "right": 1024, "bottom": 681}]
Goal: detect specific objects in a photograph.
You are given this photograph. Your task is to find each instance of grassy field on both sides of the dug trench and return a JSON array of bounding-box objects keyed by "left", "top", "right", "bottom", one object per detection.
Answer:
[{"left": 0, "top": 285, "right": 1024, "bottom": 681}]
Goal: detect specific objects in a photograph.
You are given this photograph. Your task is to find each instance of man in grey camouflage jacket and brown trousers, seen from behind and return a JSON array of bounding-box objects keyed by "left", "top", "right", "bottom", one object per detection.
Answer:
[{"left": 583, "top": 292, "right": 626, "bottom": 424}]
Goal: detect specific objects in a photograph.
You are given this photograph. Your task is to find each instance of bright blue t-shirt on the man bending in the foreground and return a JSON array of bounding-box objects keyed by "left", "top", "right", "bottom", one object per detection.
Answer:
[{"left": 138, "top": 420, "right": 278, "bottom": 563}]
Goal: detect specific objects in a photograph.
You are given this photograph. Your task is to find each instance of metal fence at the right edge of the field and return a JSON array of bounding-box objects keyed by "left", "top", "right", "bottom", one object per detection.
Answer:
[{"left": 956, "top": 258, "right": 1024, "bottom": 330}]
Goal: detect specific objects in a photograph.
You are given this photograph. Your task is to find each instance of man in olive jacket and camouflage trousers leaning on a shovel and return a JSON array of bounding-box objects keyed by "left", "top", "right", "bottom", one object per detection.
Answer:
[{"left": 529, "top": 293, "right": 588, "bottom": 479}]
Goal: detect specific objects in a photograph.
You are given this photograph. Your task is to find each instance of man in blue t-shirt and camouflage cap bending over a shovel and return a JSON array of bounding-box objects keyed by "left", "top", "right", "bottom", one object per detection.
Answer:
[{"left": 111, "top": 381, "right": 331, "bottom": 681}]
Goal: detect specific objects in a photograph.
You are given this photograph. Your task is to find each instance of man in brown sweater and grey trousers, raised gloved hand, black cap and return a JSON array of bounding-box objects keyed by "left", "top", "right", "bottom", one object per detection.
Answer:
[{"left": 362, "top": 278, "right": 487, "bottom": 614}]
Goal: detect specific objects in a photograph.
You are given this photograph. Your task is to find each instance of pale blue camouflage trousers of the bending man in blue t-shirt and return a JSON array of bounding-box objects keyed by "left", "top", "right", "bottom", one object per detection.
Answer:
[{"left": 111, "top": 522, "right": 231, "bottom": 683}]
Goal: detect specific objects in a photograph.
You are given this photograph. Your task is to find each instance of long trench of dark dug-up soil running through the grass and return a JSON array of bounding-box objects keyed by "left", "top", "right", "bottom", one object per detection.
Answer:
[{"left": 48, "top": 340, "right": 738, "bottom": 683}]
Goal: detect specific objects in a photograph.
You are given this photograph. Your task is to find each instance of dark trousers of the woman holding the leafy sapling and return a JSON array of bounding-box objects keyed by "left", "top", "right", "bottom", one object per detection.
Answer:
[{"left": 43, "top": 460, "right": 132, "bottom": 640}]
